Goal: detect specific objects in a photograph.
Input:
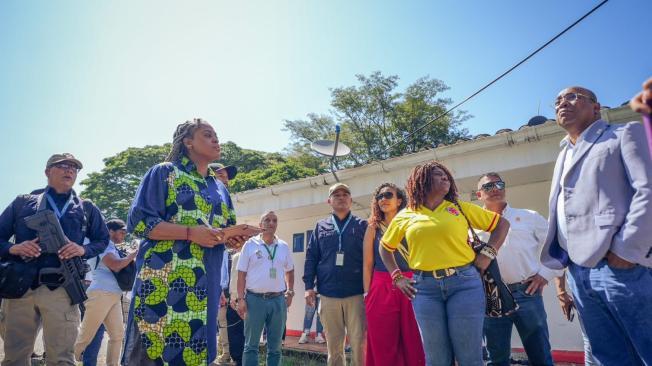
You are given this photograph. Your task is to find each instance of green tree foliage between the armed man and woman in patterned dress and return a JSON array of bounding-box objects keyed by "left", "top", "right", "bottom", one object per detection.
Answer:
[{"left": 80, "top": 144, "right": 171, "bottom": 220}]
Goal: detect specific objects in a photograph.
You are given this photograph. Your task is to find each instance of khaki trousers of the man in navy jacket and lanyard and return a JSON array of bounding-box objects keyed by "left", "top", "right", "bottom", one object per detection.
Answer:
[{"left": 319, "top": 295, "right": 366, "bottom": 366}]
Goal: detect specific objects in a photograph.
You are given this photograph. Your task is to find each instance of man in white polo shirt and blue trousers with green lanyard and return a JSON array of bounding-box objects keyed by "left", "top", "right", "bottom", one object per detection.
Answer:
[{"left": 237, "top": 211, "right": 294, "bottom": 366}]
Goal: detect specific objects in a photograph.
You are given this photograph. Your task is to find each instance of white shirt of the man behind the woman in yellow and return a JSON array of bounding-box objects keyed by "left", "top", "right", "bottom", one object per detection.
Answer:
[{"left": 478, "top": 205, "right": 563, "bottom": 284}]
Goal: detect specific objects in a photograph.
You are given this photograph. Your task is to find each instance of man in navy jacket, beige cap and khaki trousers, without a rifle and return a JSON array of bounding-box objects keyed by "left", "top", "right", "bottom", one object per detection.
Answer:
[{"left": 303, "top": 183, "right": 367, "bottom": 366}]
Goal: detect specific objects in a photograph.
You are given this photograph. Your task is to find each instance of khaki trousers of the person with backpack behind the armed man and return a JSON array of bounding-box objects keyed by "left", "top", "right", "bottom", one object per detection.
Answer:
[{"left": 75, "top": 290, "right": 125, "bottom": 366}]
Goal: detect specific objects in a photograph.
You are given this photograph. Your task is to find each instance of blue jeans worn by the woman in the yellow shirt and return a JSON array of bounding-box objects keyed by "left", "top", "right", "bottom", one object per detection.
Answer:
[{"left": 412, "top": 265, "right": 485, "bottom": 366}]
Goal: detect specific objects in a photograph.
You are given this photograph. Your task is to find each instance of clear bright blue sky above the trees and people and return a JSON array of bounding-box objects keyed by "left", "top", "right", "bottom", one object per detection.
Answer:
[{"left": 0, "top": 0, "right": 652, "bottom": 206}]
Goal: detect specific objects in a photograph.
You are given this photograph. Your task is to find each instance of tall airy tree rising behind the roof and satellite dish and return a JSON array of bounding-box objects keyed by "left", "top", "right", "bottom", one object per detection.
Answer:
[{"left": 285, "top": 72, "right": 470, "bottom": 166}]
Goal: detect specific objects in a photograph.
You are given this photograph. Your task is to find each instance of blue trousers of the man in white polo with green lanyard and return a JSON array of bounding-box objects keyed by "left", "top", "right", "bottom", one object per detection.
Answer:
[{"left": 242, "top": 292, "right": 287, "bottom": 366}]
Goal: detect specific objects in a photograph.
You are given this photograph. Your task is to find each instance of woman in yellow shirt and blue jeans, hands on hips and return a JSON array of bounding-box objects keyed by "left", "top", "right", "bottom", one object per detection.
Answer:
[{"left": 379, "top": 162, "right": 509, "bottom": 366}]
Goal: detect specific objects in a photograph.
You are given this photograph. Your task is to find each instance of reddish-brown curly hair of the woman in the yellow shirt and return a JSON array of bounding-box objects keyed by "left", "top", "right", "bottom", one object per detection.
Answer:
[{"left": 405, "top": 161, "right": 458, "bottom": 209}]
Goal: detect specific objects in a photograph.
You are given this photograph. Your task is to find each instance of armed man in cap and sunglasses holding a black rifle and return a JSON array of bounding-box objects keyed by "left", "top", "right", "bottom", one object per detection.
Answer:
[{"left": 0, "top": 153, "right": 109, "bottom": 366}]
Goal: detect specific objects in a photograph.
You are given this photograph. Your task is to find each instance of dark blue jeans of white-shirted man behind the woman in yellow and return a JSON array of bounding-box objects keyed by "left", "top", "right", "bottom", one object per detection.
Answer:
[{"left": 484, "top": 283, "right": 553, "bottom": 366}]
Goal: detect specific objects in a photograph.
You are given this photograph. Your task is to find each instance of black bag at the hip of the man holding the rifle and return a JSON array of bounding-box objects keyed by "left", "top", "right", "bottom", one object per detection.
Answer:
[{"left": 0, "top": 256, "right": 38, "bottom": 299}]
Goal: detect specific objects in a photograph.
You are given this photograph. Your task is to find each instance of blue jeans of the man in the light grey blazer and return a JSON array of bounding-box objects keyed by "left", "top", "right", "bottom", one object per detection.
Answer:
[{"left": 568, "top": 259, "right": 652, "bottom": 365}]
